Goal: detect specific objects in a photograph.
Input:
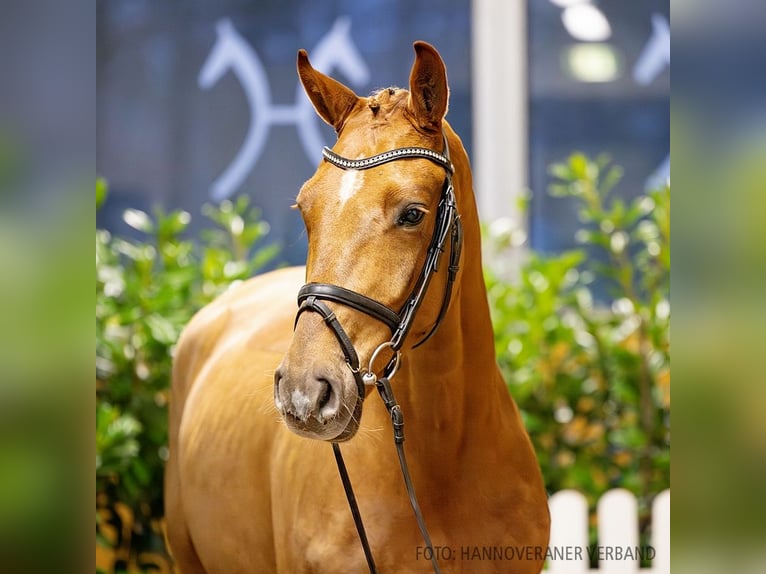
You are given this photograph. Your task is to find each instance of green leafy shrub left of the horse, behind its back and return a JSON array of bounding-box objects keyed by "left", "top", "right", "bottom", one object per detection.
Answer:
[{"left": 96, "top": 186, "right": 278, "bottom": 572}]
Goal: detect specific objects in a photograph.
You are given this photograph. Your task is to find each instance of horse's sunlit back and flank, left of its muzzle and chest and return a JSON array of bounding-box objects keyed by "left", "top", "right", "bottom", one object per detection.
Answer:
[{"left": 170, "top": 268, "right": 304, "bottom": 572}]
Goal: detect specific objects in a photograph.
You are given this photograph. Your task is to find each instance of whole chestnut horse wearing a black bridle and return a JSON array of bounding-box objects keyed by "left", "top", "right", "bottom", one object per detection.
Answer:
[{"left": 165, "top": 42, "right": 550, "bottom": 574}]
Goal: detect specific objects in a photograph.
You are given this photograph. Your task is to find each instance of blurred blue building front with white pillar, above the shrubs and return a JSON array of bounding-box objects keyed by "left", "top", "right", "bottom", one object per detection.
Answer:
[{"left": 96, "top": 0, "right": 670, "bottom": 264}]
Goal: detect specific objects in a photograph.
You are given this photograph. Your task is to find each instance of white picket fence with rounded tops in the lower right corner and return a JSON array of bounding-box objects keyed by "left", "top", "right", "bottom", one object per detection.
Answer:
[{"left": 545, "top": 489, "right": 670, "bottom": 574}]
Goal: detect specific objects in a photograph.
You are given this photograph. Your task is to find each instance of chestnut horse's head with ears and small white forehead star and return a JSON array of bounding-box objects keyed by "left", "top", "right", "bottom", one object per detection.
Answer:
[{"left": 274, "top": 42, "right": 460, "bottom": 442}]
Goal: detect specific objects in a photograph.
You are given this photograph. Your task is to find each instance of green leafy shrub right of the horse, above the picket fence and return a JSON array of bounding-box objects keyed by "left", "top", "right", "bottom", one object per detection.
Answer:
[{"left": 485, "top": 154, "right": 670, "bottom": 544}]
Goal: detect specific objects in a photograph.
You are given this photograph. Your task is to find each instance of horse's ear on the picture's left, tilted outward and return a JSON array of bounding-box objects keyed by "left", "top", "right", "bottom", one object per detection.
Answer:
[{"left": 298, "top": 50, "right": 359, "bottom": 132}]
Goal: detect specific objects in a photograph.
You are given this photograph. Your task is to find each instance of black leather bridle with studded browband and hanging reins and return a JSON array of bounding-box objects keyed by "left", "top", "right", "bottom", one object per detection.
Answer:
[{"left": 295, "top": 135, "right": 463, "bottom": 574}]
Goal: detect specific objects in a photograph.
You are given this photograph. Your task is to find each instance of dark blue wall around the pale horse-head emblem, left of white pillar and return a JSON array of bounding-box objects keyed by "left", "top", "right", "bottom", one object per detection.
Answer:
[{"left": 97, "top": 0, "right": 471, "bottom": 263}]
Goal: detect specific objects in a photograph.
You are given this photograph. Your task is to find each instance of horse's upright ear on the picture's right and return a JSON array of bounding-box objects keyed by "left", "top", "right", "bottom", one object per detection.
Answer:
[{"left": 407, "top": 42, "right": 449, "bottom": 130}]
